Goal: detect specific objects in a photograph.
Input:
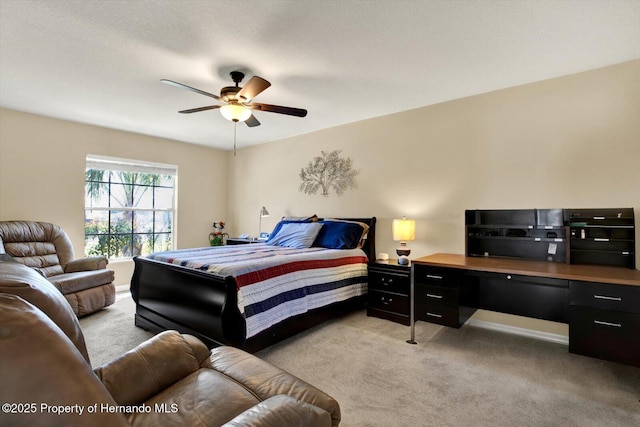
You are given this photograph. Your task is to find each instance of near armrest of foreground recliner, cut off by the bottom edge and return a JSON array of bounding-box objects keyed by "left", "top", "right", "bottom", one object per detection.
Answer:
[{"left": 223, "top": 394, "right": 331, "bottom": 427}]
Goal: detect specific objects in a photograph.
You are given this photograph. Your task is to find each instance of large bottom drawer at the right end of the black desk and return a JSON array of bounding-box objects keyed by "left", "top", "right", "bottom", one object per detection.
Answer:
[{"left": 569, "top": 306, "right": 640, "bottom": 366}]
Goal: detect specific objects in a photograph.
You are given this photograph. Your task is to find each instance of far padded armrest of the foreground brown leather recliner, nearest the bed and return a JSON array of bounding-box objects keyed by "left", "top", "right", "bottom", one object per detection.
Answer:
[{"left": 95, "top": 331, "right": 200, "bottom": 405}]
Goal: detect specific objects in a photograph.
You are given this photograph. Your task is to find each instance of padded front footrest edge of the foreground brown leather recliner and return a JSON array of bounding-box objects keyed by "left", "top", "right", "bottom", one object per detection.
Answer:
[{"left": 209, "top": 346, "right": 341, "bottom": 426}]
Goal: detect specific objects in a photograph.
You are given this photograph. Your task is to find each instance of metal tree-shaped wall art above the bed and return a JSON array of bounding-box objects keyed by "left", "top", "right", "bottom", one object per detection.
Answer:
[{"left": 298, "top": 150, "right": 359, "bottom": 197}]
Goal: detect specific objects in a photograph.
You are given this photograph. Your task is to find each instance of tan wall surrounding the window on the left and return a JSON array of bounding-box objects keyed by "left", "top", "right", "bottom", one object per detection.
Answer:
[{"left": 0, "top": 109, "right": 228, "bottom": 285}]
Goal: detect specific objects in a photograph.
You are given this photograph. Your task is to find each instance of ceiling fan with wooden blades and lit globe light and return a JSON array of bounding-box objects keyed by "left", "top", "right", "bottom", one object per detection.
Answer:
[{"left": 160, "top": 71, "right": 307, "bottom": 127}]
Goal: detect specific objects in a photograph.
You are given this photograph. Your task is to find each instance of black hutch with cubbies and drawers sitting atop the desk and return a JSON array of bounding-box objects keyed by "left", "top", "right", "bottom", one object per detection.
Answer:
[{"left": 465, "top": 208, "right": 635, "bottom": 268}]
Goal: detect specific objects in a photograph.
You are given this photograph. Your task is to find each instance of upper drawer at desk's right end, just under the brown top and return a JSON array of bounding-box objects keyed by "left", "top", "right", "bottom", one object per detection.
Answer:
[{"left": 569, "top": 281, "right": 640, "bottom": 313}]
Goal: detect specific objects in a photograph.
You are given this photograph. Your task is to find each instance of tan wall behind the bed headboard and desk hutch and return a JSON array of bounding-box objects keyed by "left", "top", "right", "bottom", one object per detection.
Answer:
[{"left": 229, "top": 61, "right": 640, "bottom": 334}]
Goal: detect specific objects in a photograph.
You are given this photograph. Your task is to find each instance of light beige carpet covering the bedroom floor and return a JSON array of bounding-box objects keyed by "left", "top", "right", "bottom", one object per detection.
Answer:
[{"left": 81, "top": 295, "right": 640, "bottom": 427}]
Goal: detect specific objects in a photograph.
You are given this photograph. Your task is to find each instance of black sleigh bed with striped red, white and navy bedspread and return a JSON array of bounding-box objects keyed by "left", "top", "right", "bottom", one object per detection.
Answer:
[{"left": 131, "top": 217, "right": 376, "bottom": 352}]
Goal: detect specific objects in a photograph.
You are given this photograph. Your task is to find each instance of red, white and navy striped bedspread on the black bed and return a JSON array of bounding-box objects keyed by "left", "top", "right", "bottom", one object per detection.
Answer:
[{"left": 148, "top": 243, "right": 367, "bottom": 338}]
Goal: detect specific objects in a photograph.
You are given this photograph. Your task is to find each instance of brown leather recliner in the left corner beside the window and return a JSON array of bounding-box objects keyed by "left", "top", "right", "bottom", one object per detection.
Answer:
[{"left": 0, "top": 221, "right": 116, "bottom": 317}]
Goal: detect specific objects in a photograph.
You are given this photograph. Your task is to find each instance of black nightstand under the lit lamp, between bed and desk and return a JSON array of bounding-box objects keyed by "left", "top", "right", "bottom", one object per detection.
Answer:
[{"left": 367, "top": 259, "right": 411, "bottom": 326}]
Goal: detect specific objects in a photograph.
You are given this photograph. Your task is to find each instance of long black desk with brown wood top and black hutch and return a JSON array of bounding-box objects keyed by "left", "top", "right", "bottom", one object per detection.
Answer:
[{"left": 409, "top": 208, "right": 640, "bottom": 366}]
